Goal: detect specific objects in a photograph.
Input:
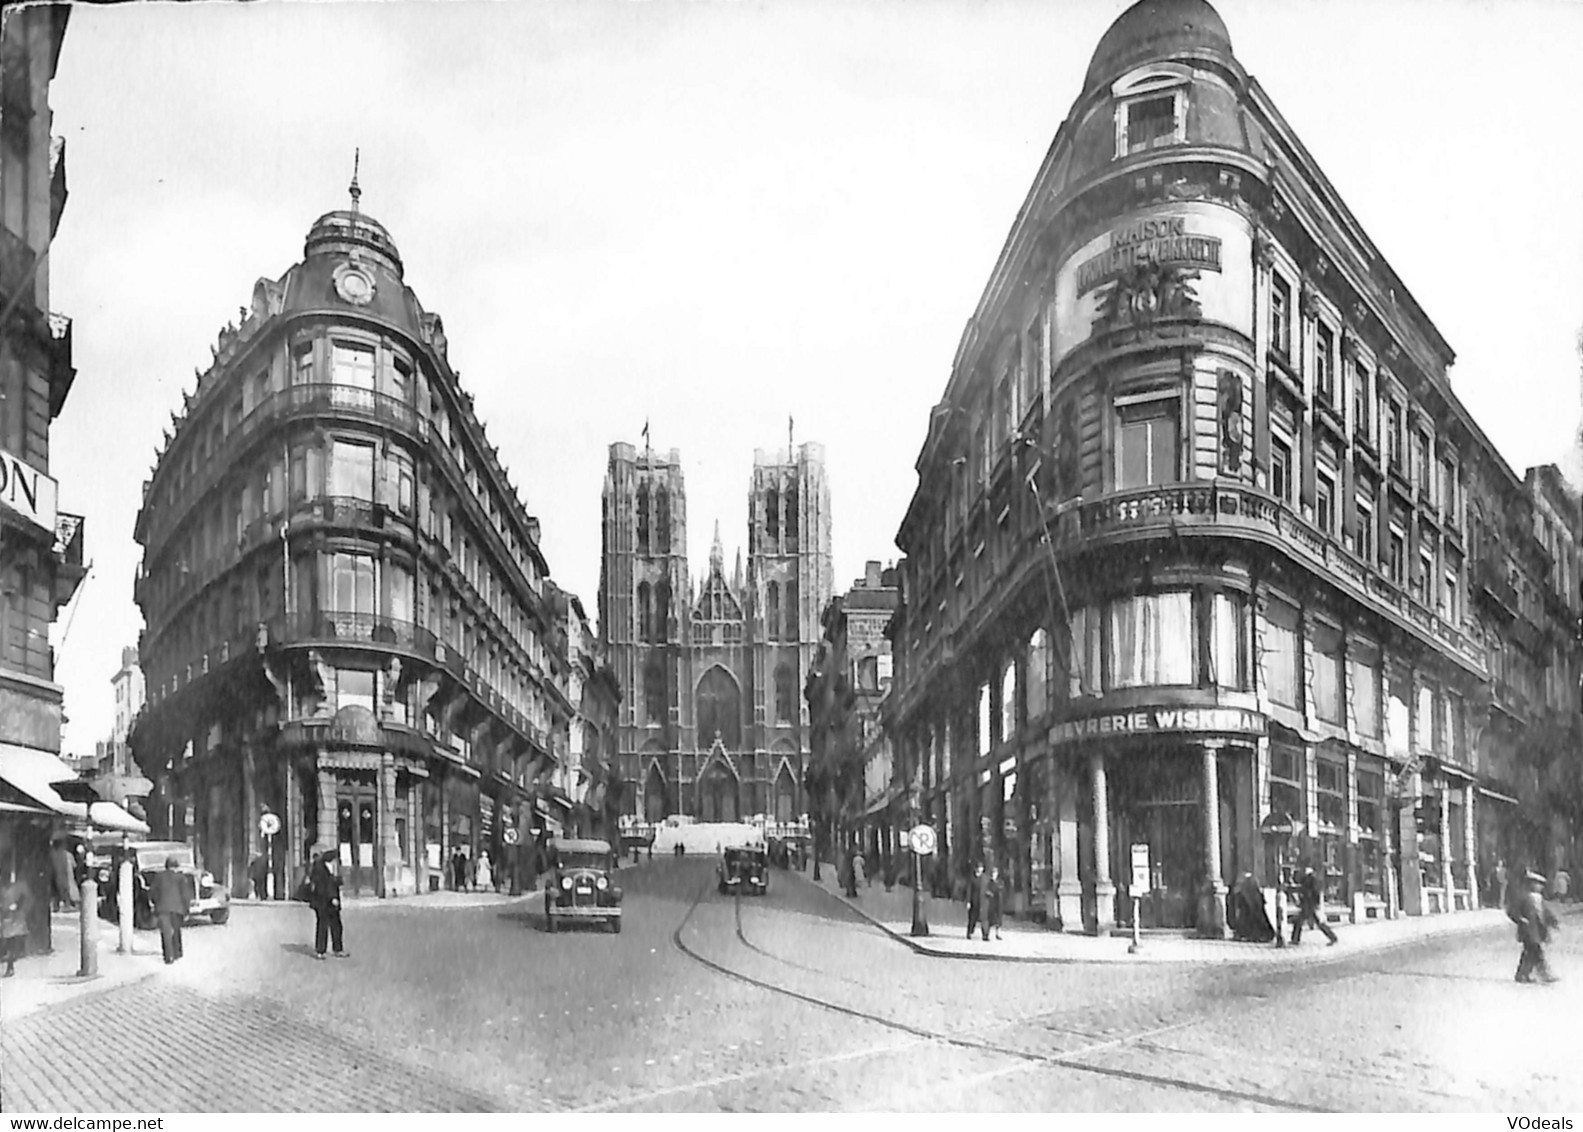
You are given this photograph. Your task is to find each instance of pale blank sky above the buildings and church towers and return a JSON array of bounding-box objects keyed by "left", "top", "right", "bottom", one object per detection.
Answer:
[{"left": 37, "top": 0, "right": 1583, "bottom": 754}]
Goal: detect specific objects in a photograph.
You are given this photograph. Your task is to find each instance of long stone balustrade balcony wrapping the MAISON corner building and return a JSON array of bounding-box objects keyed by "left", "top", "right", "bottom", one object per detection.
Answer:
[{"left": 1051, "top": 481, "right": 1485, "bottom": 670}]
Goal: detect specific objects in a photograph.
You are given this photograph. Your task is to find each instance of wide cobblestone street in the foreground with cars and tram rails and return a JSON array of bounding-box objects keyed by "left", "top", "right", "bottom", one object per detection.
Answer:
[{"left": 0, "top": 861, "right": 1583, "bottom": 1113}]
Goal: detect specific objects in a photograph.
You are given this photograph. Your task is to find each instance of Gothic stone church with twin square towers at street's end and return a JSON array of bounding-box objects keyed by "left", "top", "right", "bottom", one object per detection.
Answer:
[{"left": 600, "top": 443, "right": 831, "bottom": 823}]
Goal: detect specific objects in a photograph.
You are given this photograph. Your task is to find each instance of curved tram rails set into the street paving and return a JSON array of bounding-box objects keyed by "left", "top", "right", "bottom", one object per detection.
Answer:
[{"left": 671, "top": 883, "right": 1330, "bottom": 1113}]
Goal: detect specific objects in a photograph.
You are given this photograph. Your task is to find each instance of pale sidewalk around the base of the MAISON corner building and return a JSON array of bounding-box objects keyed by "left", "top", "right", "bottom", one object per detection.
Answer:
[{"left": 804, "top": 864, "right": 1583, "bottom": 964}]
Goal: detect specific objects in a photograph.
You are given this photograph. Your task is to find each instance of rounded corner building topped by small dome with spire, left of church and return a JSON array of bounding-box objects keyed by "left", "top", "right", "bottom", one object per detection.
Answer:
[{"left": 131, "top": 177, "right": 573, "bottom": 896}]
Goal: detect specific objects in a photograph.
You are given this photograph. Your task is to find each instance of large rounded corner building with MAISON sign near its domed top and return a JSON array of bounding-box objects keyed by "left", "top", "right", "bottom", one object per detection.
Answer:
[{"left": 888, "top": 0, "right": 1577, "bottom": 936}]
